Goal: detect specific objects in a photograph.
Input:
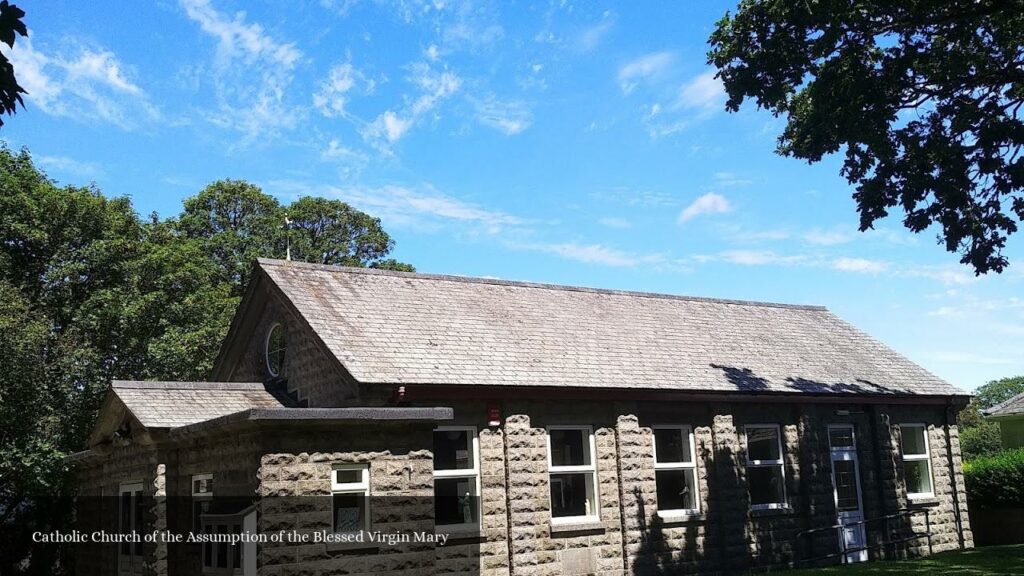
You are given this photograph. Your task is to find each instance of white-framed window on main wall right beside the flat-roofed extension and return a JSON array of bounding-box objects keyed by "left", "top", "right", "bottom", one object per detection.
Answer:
[{"left": 433, "top": 426, "right": 480, "bottom": 529}]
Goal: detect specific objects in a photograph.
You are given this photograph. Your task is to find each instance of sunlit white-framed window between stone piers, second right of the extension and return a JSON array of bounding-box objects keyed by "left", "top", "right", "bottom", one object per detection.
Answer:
[{"left": 548, "top": 426, "right": 599, "bottom": 523}]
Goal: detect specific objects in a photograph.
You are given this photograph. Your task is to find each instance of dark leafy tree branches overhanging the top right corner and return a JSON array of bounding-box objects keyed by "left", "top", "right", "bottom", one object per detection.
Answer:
[{"left": 708, "top": 0, "right": 1024, "bottom": 275}]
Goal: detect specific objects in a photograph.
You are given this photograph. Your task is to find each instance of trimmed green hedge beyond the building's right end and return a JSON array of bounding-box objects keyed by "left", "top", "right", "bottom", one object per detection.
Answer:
[{"left": 964, "top": 448, "right": 1024, "bottom": 507}]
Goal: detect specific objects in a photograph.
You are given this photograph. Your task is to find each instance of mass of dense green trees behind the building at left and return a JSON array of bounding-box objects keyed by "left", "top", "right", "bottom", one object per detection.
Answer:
[{"left": 0, "top": 148, "right": 412, "bottom": 574}]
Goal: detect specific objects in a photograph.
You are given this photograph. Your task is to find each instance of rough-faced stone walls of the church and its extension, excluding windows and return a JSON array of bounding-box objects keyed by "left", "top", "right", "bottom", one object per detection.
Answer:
[{"left": 79, "top": 400, "right": 973, "bottom": 576}]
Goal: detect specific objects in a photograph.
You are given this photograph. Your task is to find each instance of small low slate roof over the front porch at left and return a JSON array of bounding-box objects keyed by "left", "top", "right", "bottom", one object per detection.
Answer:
[{"left": 111, "top": 380, "right": 285, "bottom": 428}]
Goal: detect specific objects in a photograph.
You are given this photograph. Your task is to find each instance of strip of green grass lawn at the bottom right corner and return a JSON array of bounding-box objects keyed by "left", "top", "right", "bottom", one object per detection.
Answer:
[{"left": 793, "top": 544, "right": 1024, "bottom": 576}]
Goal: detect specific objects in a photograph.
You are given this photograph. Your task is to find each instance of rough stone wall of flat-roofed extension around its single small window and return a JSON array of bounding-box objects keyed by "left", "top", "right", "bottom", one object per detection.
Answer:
[{"left": 258, "top": 423, "right": 436, "bottom": 576}]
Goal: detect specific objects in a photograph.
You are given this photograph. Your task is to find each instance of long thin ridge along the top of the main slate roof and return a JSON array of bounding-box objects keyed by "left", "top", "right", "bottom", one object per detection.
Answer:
[{"left": 257, "top": 258, "right": 828, "bottom": 312}]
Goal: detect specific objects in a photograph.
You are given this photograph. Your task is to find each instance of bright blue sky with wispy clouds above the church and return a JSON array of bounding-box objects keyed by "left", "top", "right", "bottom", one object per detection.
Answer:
[{"left": 0, "top": 0, "right": 1024, "bottom": 389}]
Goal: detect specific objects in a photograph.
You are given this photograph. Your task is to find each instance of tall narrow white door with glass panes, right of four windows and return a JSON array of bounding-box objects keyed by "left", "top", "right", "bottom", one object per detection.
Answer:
[{"left": 828, "top": 424, "right": 867, "bottom": 563}]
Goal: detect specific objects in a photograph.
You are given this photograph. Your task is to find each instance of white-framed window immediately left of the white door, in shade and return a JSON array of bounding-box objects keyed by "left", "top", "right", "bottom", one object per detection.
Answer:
[{"left": 743, "top": 424, "right": 786, "bottom": 510}]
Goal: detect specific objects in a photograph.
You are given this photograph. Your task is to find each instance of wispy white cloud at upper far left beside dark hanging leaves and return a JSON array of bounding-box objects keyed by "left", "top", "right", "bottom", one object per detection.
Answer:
[{"left": 2, "top": 38, "right": 160, "bottom": 130}]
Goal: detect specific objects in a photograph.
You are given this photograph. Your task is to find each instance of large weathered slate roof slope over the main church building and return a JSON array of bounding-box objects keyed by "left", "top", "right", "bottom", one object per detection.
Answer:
[{"left": 259, "top": 259, "right": 966, "bottom": 396}]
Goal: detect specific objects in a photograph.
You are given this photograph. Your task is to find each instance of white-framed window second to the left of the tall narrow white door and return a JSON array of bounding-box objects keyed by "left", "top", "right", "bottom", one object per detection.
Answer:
[{"left": 651, "top": 424, "right": 700, "bottom": 516}]
